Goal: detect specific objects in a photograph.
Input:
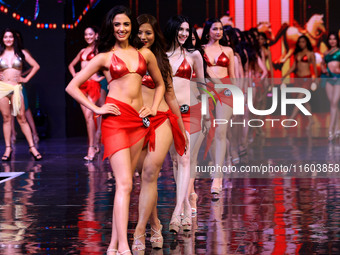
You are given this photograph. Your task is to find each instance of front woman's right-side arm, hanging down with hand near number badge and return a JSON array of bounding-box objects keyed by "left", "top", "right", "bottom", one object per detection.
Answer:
[{"left": 139, "top": 48, "right": 165, "bottom": 117}]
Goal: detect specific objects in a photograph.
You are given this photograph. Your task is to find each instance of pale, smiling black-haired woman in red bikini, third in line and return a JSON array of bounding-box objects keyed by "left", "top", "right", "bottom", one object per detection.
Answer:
[{"left": 164, "top": 15, "right": 204, "bottom": 235}]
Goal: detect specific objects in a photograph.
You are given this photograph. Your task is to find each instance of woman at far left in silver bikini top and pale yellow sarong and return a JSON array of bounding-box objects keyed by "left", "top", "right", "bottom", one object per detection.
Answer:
[{"left": 0, "top": 28, "right": 42, "bottom": 161}]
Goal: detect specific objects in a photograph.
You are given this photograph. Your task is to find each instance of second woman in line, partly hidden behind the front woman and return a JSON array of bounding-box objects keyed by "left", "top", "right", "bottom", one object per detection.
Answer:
[{"left": 132, "top": 14, "right": 187, "bottom": 251}]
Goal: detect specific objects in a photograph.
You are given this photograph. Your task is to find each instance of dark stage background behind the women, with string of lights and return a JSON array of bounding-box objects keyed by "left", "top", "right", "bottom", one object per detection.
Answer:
[{"left": 0, "top": 0, "right": 340, "bottom": 138}]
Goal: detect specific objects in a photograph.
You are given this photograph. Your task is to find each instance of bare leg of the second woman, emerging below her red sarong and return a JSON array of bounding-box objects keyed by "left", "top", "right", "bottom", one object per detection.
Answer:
[{"left": 134, "top": 120, "right": 173, "bottom": 249}]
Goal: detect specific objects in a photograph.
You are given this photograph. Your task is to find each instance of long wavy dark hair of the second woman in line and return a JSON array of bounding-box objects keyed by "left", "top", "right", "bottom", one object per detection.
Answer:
[{"left": 137, "top": 14, "right": 172, "bottom": 89}]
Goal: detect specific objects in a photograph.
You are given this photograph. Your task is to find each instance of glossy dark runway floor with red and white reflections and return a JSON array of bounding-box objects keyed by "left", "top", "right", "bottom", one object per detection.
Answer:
[{"left": 0, "top": 127, "right": 340, "bottom": 255}]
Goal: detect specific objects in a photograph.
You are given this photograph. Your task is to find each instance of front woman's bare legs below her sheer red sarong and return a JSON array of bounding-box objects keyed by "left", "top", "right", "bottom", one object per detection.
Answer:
[{"left": 109, "top": 136, "right": 144, "bottom": 252}]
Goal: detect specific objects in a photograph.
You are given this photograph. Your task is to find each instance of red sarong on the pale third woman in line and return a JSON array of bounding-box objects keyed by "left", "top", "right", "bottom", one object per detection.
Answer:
[{"left": 181, "top": 103, "right": 202, "bottom": 134}]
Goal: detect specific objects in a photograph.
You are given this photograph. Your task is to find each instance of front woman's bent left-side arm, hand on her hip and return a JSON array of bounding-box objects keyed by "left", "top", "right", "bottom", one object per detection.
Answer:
[{"left": 65, "top": 54, "right": 120, "bottom": 115}]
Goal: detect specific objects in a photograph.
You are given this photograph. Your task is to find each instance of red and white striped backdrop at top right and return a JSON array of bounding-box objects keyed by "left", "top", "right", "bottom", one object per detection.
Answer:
[{"left": 229, "top": 0, "right": 294, "bottom": 77}]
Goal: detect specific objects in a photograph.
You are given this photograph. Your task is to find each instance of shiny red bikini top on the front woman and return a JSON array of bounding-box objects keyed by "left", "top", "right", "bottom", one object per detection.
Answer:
[{"left": 109, "top": 48, "right": 146, "bottom": 83}]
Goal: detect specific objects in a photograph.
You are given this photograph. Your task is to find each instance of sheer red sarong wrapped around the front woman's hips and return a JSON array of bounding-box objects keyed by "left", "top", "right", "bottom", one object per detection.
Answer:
[{"left": 102, "top": 97, "right": 155, "bottom": 160}]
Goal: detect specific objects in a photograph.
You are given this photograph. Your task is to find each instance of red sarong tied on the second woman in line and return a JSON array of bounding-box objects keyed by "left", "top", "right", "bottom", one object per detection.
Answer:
[{"left": 146, "top": 109, "right": 185, "bottom": 156}]
